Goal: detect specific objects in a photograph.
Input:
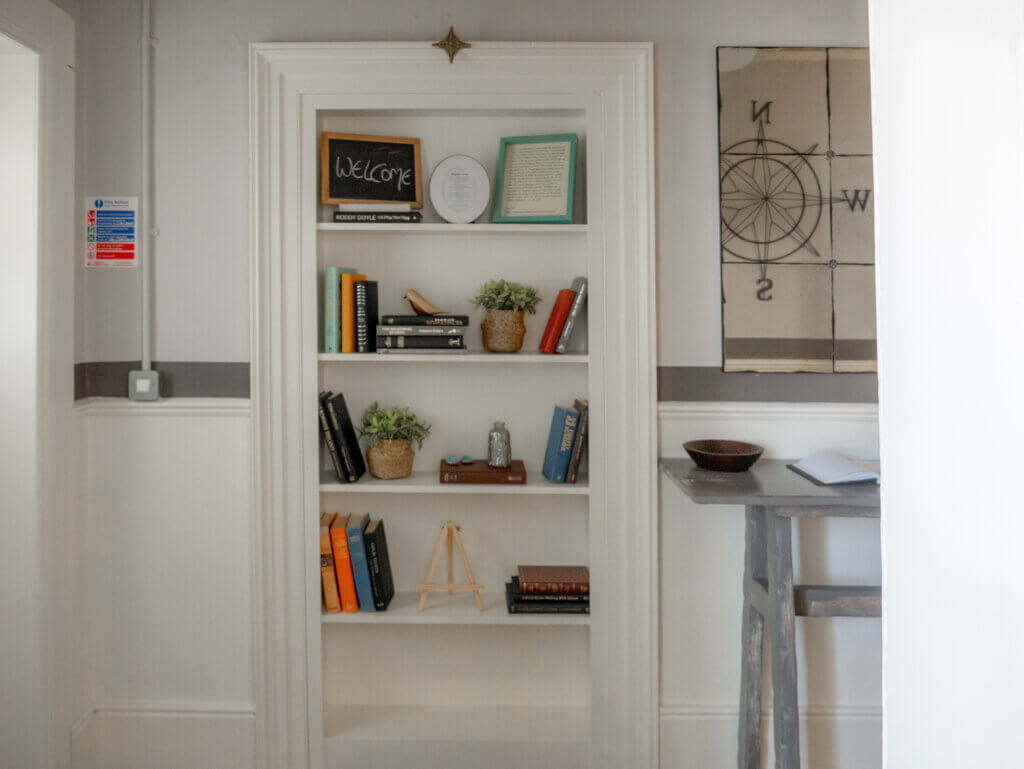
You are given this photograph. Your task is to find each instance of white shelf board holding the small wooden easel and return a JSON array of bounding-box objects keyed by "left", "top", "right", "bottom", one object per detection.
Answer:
[{"left": 321, "top": 591, "right": 590, "bottom": 626}]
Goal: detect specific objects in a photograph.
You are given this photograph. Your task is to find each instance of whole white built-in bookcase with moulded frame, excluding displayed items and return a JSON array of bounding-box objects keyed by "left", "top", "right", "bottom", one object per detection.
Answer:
[{"left": 250, "top": 42, "right": 658, "bottom": 769}]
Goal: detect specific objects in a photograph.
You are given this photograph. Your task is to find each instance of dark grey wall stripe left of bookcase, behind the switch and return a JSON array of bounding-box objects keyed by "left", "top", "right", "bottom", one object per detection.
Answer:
[{"left": 75, "top": 360, "right": 249, "bottom": 400}]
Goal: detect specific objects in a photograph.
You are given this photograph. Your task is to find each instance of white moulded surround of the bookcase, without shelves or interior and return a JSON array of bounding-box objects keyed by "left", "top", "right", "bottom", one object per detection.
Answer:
[{"left": 250, "top": 42, "right": 659, "bottom": 769}]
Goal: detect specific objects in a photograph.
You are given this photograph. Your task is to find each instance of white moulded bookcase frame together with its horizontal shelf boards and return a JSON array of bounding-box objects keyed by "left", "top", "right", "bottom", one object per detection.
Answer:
[{"left": 250, "top": 42, "right": 658, "bottom": 769}]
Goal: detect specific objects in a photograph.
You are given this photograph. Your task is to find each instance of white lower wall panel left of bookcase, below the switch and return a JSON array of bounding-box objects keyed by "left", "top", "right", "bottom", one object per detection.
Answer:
[{"left": 73, "top": 398, "right": 255, "bottom": 769}]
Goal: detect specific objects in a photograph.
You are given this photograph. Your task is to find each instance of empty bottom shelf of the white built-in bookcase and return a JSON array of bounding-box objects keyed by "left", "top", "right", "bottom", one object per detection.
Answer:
[{"left": 324, "top": 704, "right": 590, "bottom": 744}]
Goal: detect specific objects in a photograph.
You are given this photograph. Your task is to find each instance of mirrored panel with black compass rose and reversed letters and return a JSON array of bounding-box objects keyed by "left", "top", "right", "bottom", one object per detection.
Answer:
[{"left": 718, "top": 48, "right": 876, "bottom": 373}]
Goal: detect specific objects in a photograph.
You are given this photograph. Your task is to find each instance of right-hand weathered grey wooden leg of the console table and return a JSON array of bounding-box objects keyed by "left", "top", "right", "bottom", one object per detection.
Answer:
[{"left": 766, "top": 508, "right": 800, "bottom": 769}]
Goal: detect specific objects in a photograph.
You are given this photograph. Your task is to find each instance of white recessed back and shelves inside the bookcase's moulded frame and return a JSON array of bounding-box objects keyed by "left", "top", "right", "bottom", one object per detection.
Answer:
[{"left": 310, "top": 100, "right": 603, "bottom": 769}]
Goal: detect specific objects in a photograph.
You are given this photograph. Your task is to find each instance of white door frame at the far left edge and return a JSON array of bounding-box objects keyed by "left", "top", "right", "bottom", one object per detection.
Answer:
[{"left": 0, "top": 6, "right": 74, "bottom": 769}]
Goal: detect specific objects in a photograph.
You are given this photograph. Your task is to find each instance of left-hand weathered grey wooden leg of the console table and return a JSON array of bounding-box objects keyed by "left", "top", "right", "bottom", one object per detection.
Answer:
[{"left": 738, "top": 506, "right": 766, "bottom": 769}]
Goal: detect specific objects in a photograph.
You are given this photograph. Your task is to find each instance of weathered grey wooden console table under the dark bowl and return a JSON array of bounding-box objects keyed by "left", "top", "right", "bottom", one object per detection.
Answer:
[{"left": 658, "top": 459, "right": 882, "bottom": 769}]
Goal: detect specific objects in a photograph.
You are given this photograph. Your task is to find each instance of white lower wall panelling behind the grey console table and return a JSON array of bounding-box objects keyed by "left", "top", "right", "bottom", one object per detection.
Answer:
[{"left": 658, "top": 402, "right": 882, "bottom": 769}]
